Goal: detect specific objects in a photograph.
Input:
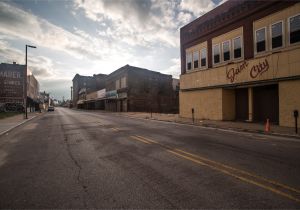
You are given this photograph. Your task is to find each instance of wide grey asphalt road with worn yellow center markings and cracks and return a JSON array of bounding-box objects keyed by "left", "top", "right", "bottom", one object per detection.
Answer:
[{"left": 0, "top": 108, "right": 300, "bottom": 209}]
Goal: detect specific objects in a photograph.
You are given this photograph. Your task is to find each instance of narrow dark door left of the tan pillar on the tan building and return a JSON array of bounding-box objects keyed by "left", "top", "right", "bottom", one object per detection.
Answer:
[{"left": 235, "top": 88, "right": 248, "bottom": 121}]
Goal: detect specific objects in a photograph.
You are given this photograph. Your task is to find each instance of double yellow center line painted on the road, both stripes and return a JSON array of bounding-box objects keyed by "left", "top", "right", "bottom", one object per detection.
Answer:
[{"left": 130, "top": 135, "right": 300, "bottom": 203}]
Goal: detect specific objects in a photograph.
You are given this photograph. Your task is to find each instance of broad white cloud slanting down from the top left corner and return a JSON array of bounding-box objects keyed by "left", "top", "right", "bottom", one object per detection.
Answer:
[{"left": 0, "top": 2, "right": 103, "bottom": 59}]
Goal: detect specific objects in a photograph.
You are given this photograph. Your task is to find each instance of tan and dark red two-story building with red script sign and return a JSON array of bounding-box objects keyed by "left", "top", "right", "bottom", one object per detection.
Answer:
[{"left": 180, "top": 0, "right": 300, "bottom": 127}]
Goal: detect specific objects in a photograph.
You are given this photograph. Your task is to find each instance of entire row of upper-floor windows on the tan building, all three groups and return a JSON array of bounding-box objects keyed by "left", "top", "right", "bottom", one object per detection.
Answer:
[{"left": 186, "top": 14, "right": 300, "bottom": 70}]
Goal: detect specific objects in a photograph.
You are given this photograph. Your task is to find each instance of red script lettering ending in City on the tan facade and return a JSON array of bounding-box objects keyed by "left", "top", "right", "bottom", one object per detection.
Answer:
[{"left": 226, "top": 58, "right": 270, "bottom": 83}]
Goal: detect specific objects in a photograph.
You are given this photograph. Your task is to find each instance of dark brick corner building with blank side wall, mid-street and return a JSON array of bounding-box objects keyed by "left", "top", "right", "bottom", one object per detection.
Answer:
[{"left": 105, "top": 65, "right": 178, "bottom": 113}]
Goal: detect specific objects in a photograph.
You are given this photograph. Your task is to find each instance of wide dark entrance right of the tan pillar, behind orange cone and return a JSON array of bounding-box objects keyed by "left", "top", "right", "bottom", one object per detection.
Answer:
[{"left": 253, "top": 84, "right": 279, "bottom": 123}]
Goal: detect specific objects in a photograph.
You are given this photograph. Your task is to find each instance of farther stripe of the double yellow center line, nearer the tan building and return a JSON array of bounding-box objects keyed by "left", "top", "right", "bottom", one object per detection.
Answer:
[{"left": 175, "top": 149, "right": 300, "bottom": 193}]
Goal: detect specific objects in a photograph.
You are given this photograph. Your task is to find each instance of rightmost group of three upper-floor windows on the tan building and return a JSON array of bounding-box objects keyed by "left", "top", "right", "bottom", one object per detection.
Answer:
[{"left": 255, "top": 14, "right": 300, "bottom": 53}]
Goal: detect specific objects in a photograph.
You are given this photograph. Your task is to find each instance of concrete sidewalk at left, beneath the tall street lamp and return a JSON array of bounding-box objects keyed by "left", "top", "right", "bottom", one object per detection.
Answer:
[{"left": 0, "top": 112, "right": 41, "bottom": 136}]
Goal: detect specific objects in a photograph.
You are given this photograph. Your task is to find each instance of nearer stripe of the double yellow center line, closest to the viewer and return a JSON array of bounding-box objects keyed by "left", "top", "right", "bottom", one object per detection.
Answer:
[{"left": 167, "top": 150, "right": 300, "bottom": 202}]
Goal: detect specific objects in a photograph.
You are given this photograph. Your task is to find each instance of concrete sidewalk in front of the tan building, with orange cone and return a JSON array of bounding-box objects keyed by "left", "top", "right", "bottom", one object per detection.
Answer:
[{"left": 108, "top": 112, "right": 300, "bottom": 139}]
